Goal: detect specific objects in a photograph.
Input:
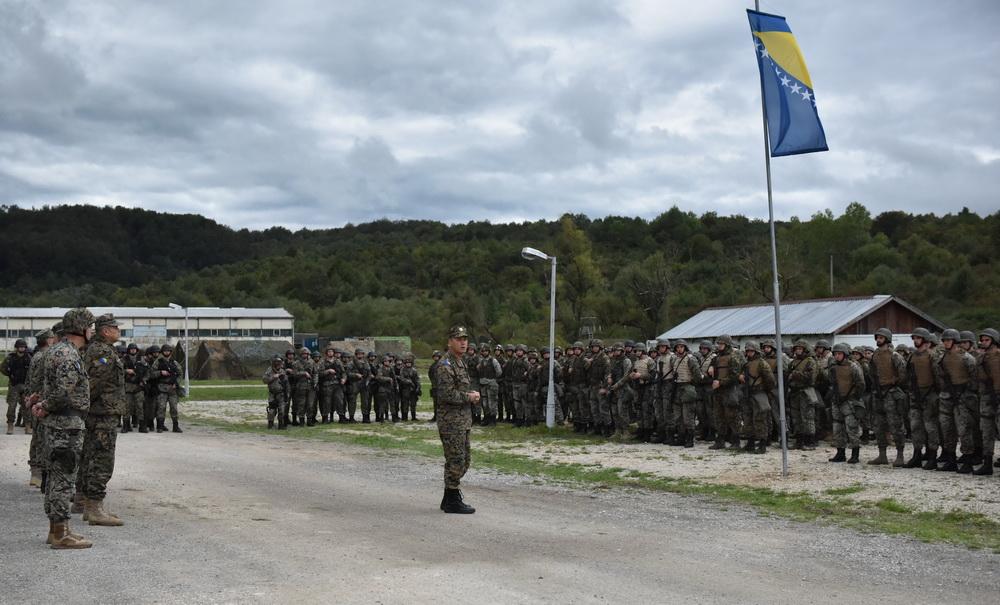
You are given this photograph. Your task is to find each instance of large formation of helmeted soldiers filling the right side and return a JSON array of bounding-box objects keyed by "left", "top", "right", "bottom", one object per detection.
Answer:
[{"left": 414, "top": 328, "right": 1000, "bottom": 475}]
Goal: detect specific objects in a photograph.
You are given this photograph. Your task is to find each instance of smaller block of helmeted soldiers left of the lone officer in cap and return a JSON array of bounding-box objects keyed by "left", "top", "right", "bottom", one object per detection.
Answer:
[{"left": 263, "top": 344, "right": 423, "bottom": 430}]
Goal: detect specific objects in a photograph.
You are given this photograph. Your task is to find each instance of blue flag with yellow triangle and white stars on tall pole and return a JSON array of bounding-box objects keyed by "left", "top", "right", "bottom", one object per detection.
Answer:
[{"left": 747, "top": 9, "right": 829, "bottom": 157}]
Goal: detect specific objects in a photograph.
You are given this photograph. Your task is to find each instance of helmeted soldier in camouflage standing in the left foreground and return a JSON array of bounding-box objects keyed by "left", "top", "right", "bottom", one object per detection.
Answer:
[{"left": 29, "top": 309, "right": 94, "bottom": 549}]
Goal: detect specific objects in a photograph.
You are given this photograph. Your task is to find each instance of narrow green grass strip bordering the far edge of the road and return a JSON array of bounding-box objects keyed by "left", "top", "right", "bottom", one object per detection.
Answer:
[{"left": 188, "top": 419, "right": 1000, "bottom": 553}]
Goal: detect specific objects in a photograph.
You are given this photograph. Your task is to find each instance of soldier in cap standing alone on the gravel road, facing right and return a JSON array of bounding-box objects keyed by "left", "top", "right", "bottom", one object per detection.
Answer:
[{"left": 436, "top": 326, "right": 479, "bottom": 514}]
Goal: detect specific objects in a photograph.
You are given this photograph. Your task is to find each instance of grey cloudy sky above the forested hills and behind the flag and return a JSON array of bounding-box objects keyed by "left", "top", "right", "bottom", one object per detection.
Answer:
[{"left": 0, "top": 0, "right": 1000, "bottom": 228}]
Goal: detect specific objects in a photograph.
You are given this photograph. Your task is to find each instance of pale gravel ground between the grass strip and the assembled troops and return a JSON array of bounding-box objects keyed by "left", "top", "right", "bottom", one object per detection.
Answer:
[{"left": 189, "top": 401, "right": 1000, "bottom": 521}]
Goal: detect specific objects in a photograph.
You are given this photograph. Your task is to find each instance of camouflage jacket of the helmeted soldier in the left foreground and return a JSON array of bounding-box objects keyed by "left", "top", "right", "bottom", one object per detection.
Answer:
[{"left": 42, "top": 340, "right": 90, "bottom": 430}]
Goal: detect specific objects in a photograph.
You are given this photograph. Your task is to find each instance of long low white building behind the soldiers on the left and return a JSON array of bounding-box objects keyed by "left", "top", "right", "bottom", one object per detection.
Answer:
[{"left": 0, "top": 307, "right": 295, "bottom": 351}]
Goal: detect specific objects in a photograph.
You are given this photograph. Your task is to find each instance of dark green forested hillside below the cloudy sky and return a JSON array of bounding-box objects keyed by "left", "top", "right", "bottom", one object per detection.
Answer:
[{"left": 0, "top": 203, "right": 1000, "bottom": 353}]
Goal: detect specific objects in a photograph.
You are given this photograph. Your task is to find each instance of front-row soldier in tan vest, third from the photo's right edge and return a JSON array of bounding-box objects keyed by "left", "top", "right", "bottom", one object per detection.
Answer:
[{"left": 904, "top": 328, "right": 941, "bottom": 470}]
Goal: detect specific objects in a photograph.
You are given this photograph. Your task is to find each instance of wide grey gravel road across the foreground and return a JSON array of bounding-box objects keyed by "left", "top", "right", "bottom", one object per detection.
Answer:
[{"left": 0, "top": 427, "right": 1000, "bottom": 605}]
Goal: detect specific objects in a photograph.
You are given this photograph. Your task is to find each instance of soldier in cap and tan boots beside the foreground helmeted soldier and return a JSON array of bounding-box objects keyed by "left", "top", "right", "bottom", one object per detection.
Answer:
[{"left": 77, "top": 313, "right": 128, "bottom": 526}]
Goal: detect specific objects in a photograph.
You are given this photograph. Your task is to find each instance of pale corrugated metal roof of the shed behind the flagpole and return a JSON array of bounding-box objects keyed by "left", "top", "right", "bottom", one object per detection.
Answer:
[{"left": 660, "top": 294, "right": 904, "bottom": 339}]
